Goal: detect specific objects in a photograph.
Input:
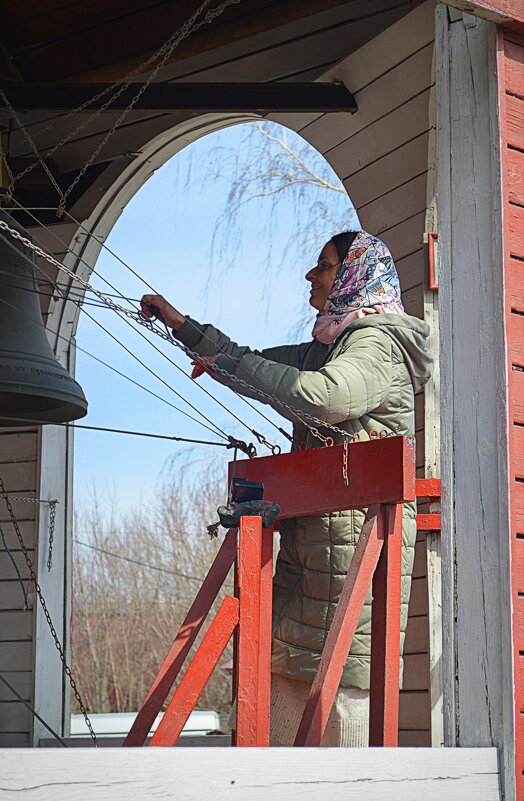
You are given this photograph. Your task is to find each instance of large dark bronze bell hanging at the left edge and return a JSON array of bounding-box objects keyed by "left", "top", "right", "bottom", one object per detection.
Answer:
[{"left": 0, "top": 212, "right": 87, "bottom": 426}]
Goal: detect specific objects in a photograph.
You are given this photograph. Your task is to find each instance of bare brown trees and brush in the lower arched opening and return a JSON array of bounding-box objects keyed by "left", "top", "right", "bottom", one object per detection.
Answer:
[{"left": 71, "top": 463, "right": 232, "bottom": 713}]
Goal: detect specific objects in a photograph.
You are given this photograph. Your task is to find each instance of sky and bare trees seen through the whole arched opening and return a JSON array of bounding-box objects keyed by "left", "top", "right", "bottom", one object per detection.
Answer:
[{"left": 66, "top": 115, "right": 360, "bottom": 730}]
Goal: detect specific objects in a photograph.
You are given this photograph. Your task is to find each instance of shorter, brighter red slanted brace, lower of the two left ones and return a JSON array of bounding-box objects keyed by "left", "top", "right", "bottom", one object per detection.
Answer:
[{"left": 149, "top": 595, "right": 238, "bottom": 746}]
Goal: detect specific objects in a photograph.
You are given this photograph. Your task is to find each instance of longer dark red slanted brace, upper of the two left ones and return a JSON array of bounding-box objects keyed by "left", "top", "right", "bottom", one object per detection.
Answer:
[{"left": 123, "top": 530, "right": 236, "bottom": 746}]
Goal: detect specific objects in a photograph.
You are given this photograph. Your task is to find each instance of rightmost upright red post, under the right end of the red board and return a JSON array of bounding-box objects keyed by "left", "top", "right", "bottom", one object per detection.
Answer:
[{"left": 369, "top": 503, "right": 402, "bottom": 746}]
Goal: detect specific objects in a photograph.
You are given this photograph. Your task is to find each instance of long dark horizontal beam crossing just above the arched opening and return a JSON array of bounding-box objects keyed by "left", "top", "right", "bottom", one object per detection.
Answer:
[{"left": 0, "top": 82, "right": 357, "bottom": 112}]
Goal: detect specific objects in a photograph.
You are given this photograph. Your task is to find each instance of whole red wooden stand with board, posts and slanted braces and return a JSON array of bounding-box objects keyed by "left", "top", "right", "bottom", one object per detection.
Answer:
[{"left": 124, "top": 437, "right": 440, "bottom": 746}]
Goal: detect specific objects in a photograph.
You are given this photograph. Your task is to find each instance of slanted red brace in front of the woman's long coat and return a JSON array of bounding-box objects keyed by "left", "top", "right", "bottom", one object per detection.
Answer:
[{"left": 294, "top": 506, "right": 384, "bottom": 745}]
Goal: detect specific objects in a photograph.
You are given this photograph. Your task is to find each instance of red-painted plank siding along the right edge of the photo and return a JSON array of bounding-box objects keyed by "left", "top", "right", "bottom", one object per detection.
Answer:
[{"left": 499, "top": 25, "right": 524, "bottom": 801}]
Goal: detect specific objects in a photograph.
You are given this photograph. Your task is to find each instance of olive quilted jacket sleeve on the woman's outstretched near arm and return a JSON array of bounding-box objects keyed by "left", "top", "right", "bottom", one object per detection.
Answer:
[{"left": 177, "top": 320, "right": 392, "bottom": 424}]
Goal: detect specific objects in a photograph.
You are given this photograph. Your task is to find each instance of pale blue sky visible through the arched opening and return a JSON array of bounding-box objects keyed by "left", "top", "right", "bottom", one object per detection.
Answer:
[{"left": 75, "top": 126, "right": 356, "bottom": 509}]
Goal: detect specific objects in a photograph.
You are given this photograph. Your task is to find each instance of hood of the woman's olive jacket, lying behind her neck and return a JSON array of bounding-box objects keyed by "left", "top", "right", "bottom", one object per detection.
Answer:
[{"left": 342, "top": 314, "right": 435, "bottom": 392}]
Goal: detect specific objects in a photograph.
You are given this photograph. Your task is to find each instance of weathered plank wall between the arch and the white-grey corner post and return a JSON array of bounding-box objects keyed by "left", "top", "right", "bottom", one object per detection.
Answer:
[{"left": 271, "top": 2, "right": 434, "bottom": 746}]
